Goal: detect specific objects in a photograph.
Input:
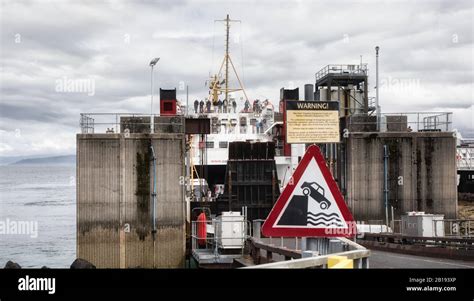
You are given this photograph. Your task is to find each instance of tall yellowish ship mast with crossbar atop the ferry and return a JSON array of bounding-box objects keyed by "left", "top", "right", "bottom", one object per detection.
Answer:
[{"left": 210, "top": 15, "right": 248, "bottom": 104}]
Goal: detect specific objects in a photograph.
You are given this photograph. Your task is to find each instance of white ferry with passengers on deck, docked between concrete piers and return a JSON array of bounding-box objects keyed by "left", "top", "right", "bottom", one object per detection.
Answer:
[{"left": 186, "top": 15, "right": 298, "bottom": 209}]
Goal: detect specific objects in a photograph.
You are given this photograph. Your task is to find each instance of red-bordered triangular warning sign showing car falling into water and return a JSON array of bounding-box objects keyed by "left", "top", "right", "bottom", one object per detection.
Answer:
[{"left": 262, "top": 145, "right": 356, "bottom": 237}]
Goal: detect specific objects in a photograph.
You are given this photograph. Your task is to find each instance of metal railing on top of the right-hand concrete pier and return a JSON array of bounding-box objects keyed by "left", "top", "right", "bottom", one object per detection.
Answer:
[{"left": 346, "top": 112, "right": 453, "bottom": 132}]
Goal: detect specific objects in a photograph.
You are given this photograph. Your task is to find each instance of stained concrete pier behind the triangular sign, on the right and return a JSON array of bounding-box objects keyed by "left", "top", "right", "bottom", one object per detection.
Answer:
[{"left": 341, "top": 132, "right": 457, "bottom": 221}]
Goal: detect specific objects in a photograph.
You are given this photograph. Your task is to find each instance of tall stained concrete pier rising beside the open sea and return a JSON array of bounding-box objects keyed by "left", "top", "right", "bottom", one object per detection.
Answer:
[{"left": 77, "top": 133, "right": 185, "bottom": 268}]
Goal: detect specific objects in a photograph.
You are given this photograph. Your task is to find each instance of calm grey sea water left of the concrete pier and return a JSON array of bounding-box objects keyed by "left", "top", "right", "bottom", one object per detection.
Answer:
[{"left": 0, "top": 164, "right": 76, "bottom": 268}]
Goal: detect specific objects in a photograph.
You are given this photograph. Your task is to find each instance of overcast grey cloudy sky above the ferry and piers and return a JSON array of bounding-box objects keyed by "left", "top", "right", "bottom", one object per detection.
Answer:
[{"left": 0, "top": 0, "right": 474, "bottom": 156}]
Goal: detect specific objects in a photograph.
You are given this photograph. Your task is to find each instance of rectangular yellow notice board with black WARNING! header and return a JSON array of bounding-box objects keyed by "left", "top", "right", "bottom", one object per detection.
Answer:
[{"left": 286, "top": 100, "right": 340, "bottom": 143}]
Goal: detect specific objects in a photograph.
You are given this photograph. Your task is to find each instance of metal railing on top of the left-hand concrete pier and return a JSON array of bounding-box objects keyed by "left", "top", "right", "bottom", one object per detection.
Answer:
[{"left": 79, "top": 113, "right": 184, "bottom": 134}]
